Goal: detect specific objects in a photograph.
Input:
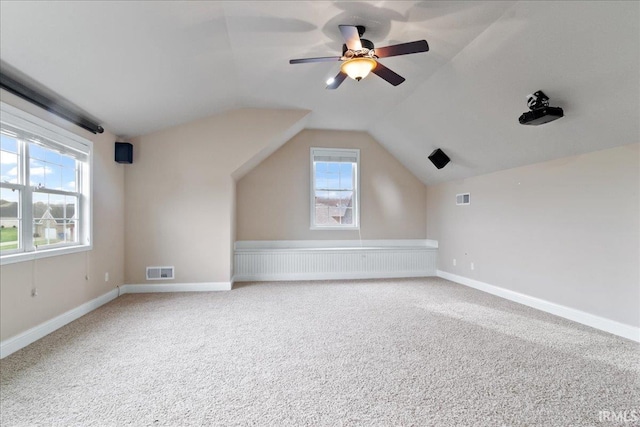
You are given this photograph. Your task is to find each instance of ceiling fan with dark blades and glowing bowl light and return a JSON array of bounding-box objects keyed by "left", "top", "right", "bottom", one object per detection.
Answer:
[{"left": 289, "top": 25, "right": 429, "bottom": 89}]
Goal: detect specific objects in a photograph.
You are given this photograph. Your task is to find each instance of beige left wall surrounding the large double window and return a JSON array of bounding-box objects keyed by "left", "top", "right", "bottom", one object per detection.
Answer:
[{"left": 0, "top": 91, "right": 127, "bottom": 340}]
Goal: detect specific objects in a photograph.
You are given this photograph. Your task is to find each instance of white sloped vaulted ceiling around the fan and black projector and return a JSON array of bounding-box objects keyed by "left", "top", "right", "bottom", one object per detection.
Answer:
[{"left": 0, "top": 1, "right": 640, "bottom": 184}]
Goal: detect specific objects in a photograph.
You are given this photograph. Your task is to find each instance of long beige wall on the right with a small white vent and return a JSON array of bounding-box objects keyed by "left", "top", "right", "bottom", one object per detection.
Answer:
[{"left": 427, "top": 144, "right": 640, "bottom": 326}]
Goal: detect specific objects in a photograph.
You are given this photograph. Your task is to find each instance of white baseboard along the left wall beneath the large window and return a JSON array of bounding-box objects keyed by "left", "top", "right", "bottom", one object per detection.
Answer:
[{"left": 0, "top": 289, "right": 118, "bottom": 359}]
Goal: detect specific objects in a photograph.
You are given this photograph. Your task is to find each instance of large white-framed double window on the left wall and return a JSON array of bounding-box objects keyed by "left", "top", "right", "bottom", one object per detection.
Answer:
[{"left": 0, "top": 104, "right": 92, "bottom": 264}]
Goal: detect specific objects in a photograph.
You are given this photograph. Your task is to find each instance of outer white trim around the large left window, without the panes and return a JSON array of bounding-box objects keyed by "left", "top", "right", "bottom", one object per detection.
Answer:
[{"left": 0, "top": 102, "right": 93, "bottom": 265}]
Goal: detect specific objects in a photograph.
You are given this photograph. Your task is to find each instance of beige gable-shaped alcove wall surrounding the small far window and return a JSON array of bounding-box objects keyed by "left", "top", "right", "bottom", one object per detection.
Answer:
[{"left": 236, "top": 130, "right": 426, "bottom": 240}]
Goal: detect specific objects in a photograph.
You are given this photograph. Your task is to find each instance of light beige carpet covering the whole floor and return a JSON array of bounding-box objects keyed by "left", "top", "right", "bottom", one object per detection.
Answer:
[{"left": 0, "top": 278, "right": 640, "bottom": 427}]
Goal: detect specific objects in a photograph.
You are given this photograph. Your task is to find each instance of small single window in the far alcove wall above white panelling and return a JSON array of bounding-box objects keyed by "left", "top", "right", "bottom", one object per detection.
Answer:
[{"left": 311, "top": 148, "right": 360, "bottom": 230}]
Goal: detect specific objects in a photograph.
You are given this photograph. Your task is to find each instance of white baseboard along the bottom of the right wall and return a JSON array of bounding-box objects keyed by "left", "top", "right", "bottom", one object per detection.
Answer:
[{"left": 437, "top": 270, "right": 640, "bottom": 342}]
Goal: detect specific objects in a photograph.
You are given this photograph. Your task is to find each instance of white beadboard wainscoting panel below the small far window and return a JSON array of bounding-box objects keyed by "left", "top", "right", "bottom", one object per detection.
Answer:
[{"left": 234, "top": 240, "right": 437, "bottom": 281}]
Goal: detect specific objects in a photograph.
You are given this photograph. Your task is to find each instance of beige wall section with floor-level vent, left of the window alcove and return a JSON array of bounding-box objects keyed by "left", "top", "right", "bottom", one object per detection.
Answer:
[{"left": 125, "top": 109, "right": 308, "bottom": 284}]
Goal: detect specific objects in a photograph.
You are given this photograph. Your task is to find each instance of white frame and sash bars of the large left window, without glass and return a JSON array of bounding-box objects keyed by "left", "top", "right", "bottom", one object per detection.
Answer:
[{"left": 0, "top": 102, "right": 93, "bottom": 265}]
